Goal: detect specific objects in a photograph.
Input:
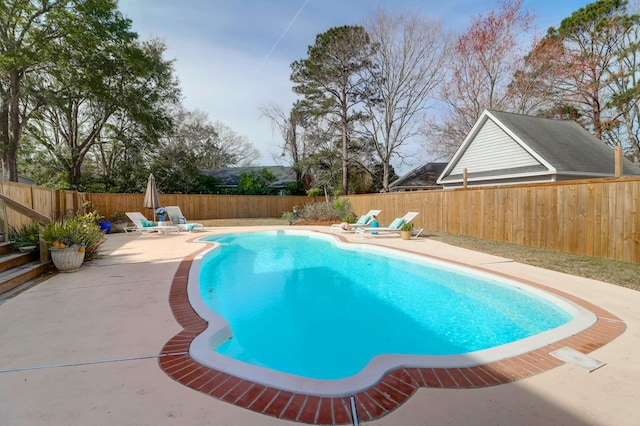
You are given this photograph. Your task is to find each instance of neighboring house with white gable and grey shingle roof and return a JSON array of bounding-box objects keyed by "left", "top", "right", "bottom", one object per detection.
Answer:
[{"left": 438, "top": 110, "right": 640, "bottom": 187}]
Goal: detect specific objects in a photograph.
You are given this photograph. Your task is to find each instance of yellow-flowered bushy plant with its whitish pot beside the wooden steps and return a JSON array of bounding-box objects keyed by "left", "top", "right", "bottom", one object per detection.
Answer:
[{"left": 42, "top": 213, "right": 104, "bottom": 272}]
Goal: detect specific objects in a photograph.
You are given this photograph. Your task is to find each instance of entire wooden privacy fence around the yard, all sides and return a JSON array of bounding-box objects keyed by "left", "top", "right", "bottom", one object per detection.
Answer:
[{"left": 1, "top": 177, "right": 640, "bottom": 262}]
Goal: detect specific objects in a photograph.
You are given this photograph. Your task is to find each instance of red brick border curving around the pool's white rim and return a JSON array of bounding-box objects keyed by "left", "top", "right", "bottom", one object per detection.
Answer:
[{"left": 158, "top": 238, "right": 626, "bottom": 424}]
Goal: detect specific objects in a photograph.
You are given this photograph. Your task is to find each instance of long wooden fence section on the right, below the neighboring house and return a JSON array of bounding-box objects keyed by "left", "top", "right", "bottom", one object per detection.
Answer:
[{"left": 346, "top": 177, "right": 640, "bottom": 262}]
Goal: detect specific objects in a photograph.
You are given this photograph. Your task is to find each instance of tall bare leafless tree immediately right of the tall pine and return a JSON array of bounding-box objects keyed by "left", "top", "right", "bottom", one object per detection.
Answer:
[{"left": 364, "top": 9, "right": 449, "bottom": 192}]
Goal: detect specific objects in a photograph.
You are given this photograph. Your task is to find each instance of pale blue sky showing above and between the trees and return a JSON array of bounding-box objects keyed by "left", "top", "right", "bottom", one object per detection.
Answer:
[{"left": 119, "top": 0, "right": 590, "bottom": 175}]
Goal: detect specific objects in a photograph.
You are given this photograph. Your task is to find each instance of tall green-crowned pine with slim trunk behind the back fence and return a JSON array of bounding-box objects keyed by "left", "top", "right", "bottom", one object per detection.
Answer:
[{"left": 291, "top": 26, "right": 373, "bottom": 194}]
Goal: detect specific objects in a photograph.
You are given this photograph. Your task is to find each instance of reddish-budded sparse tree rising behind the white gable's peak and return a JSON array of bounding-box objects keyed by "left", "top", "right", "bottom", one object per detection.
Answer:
[{"left": 431, "top": 0, "right": 533, "bottom": 157}]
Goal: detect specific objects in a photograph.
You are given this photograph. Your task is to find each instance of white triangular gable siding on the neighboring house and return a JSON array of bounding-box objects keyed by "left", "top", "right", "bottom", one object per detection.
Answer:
[{"left": 449, "top": 119, "right": 541, "bottom": 175}]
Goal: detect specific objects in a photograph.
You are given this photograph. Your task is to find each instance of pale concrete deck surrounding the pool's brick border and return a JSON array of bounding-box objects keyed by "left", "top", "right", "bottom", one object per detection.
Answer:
[{"left": 0, "top": 227, "right": 640, "bottom": 425}]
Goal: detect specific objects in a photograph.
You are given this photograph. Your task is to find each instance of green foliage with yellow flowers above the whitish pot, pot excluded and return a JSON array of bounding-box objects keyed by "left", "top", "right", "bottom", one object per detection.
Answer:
[{"left": 42, "top": 214, "right": 104, "bottom": 260}]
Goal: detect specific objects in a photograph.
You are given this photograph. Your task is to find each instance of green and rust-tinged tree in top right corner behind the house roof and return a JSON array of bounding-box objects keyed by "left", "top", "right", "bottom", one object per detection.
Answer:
[{"left": 514, "top": 0, "right": 640, "bottom": 164}]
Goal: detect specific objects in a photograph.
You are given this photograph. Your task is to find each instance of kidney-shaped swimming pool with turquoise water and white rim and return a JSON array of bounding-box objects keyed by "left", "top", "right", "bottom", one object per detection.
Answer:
[{"left": 189, "top": 231, "right": 595, "bottom": 395}]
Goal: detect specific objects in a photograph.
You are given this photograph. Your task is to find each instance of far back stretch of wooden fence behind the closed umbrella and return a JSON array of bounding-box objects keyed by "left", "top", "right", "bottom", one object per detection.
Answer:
[{"left": 86, "top": 193, "right": 309, "bottom": 221}]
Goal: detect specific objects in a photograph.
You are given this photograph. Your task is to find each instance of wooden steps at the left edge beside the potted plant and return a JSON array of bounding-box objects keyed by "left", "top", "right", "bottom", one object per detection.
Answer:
[{"left": 0, "top": 251, "right": 53, "bottom": 295}]
